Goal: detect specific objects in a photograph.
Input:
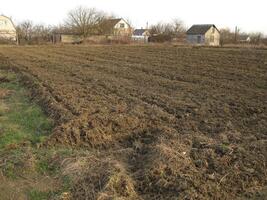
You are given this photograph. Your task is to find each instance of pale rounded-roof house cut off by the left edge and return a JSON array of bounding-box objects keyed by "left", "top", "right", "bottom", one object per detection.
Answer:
[{"left": 0, "top": 15, "right": 17, "bottom": 41}]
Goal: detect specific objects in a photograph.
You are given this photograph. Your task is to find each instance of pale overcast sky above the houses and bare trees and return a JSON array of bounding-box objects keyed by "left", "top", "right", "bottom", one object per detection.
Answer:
[{"left": 0, "top": 0, "right": 267, "bottom": 35}]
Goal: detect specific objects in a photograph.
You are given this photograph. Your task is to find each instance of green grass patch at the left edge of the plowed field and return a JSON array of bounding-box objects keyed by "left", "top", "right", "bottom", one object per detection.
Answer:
[{"left": 0, "top": 69, "right": 53, "bottom": 148}]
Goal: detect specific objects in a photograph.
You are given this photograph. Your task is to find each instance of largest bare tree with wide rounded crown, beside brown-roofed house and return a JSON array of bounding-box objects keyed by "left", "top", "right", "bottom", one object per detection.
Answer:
[{"left": 65, "top": 6, "right": 106, "bottom": 38}]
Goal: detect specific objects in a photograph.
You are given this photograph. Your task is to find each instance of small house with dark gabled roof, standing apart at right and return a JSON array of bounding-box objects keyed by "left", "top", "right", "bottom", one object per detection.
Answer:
[{"left": 186, "top": 24, "right": 220, "bottom": 46}]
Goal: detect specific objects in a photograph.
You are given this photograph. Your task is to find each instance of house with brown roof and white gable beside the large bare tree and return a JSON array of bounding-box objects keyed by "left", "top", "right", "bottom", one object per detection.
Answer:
[{"left": 100, "top": 18, "right": 132, "bottom": 36}]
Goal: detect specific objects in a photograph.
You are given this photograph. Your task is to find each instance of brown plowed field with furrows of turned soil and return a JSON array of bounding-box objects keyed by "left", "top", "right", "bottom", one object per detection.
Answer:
[{"left": 0, "top": 46, "right": 267, "bottom": 199}]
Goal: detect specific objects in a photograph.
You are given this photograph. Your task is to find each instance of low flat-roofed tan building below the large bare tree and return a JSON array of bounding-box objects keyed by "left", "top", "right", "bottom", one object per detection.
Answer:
[{"left": 53, "top": 32, "right": 83, "bottom": 44}]
